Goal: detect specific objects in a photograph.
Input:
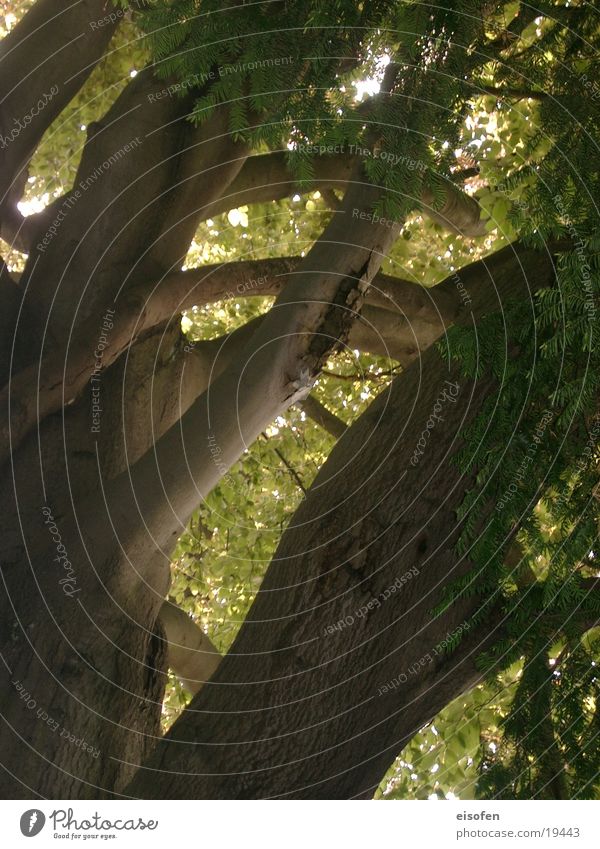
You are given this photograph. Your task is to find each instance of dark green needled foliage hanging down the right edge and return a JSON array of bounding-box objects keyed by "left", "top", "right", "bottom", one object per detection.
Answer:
[{"left": 440, "top": 5, "right": 600, "bottom": 798}]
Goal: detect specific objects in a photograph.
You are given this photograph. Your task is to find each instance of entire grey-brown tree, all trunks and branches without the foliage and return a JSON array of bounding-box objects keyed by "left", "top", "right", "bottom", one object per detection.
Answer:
[{"left": 0, "top": 0, "right": 564, "bottom": 798}]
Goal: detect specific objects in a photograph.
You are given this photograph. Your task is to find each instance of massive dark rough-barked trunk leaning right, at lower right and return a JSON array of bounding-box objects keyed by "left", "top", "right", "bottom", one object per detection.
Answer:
[{"left": 128, "top": 342, "right": 504, "bottom": 799}]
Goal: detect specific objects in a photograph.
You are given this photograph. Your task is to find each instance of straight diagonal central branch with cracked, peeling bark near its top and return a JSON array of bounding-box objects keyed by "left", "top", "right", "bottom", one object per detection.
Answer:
[{"left": 55, "top": 174, "right": 398, "bottom": 609}]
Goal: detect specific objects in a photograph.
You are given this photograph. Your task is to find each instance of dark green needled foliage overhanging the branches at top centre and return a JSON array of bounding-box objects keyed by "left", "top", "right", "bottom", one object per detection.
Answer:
[{"left": 122, "top": 0, "right": 506, "bottom": 219}]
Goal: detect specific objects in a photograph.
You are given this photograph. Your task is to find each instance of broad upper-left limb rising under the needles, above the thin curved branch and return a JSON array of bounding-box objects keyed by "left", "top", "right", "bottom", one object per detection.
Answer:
[{"left": 22, "top": 68, "right": 247, "bottom": 354}]
